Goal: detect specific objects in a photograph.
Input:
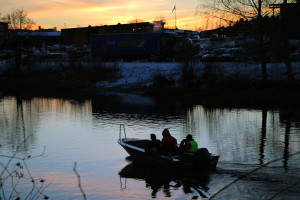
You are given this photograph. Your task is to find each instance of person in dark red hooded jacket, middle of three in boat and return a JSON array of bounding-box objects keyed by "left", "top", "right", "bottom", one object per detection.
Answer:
[{"left": 161, "top": 129, "right": 178, "bottom": 156}]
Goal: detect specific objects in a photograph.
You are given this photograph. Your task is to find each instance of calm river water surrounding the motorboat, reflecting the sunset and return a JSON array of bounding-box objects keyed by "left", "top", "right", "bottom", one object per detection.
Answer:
[{"left": 0, "top": 94, "right": 300, "bottom": 199}]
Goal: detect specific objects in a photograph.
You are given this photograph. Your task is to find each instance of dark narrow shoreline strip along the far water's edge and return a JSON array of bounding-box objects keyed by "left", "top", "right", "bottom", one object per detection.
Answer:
[{"left": 0, "top": 79, "right": 300, "bottom": 108}]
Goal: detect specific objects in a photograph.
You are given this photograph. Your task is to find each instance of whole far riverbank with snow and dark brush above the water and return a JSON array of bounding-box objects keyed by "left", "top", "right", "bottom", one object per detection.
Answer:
[{"left": 0, "top": 62, "right": 300, "bottom": 106}]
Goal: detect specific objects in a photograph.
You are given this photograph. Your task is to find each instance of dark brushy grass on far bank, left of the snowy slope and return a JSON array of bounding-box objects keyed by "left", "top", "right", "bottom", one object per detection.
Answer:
[{"left": 0, "top": 61, "right": 122, "bottom": 90}]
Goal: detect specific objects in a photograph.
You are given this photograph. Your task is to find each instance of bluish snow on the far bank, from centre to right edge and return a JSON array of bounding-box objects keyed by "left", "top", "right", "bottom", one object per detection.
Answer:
[{"left": 96, "top": 62, "right": 300, "bottom": 88}]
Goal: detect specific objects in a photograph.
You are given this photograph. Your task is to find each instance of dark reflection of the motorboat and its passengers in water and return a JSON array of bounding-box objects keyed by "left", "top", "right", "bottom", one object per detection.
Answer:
[{"left": 119, "top": 157, "right": 210, "bottom": 198}]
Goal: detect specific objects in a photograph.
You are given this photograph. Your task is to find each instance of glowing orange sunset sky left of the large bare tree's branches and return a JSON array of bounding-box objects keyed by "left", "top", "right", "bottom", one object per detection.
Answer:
[{"left": 0, "top": 0, "right": 220, "bottom": 30}]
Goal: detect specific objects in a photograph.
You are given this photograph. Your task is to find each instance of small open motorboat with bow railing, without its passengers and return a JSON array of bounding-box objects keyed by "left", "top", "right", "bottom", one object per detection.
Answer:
[{"left": 118, "top": 124, "right": 220, "bottom": 171}]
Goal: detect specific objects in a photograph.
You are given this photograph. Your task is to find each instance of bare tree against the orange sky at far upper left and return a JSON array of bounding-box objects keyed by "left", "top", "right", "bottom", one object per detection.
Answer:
[{"left": 1, "top": 8, "right": 35, "bottom": 30}]
